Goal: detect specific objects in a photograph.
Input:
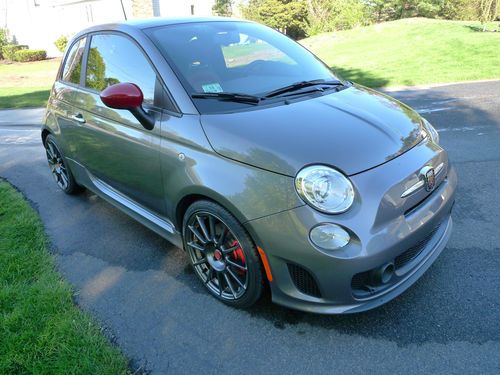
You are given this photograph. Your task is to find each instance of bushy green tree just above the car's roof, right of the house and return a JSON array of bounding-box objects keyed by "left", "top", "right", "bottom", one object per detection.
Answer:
[{"left": 241, "top": 0, "right": 308, "bottom": 39}]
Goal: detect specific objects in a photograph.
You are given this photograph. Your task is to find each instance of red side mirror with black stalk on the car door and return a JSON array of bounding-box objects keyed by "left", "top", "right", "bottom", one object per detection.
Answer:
[{"left": 100, "top": 83, "right": 155, "bottom": 130}]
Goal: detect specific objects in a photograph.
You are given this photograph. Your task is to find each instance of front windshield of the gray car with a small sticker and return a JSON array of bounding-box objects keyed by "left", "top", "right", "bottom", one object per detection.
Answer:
[{"left": 146, "top": 21, "right": 336, "bottom": 112}]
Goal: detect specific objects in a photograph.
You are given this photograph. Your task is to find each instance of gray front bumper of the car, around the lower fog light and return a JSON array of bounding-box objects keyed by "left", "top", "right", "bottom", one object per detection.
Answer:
[{"left": 245, "top": 142, "right": 457, "bottom": 314}]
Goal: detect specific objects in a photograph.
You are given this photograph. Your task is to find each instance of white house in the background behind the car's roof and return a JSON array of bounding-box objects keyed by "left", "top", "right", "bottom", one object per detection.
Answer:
[{"left": 0, "top": 0, "right": 219, "bottom": 56}]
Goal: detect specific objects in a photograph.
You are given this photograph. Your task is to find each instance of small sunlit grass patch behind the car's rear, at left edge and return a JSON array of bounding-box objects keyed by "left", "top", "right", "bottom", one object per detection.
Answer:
[{"left": 0, "top": 59, "right": 60, "bottom": 108}]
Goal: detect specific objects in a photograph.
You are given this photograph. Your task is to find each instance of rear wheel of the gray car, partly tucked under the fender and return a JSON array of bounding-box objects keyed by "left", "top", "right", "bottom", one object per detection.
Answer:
[{"left": 44, "top": 134, "right": 84, "bottom": 194}]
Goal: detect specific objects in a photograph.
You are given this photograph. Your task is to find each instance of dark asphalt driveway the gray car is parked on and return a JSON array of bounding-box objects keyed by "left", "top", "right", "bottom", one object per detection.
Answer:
[{"left": 0, "top": 82, "right": 500, "bottom": 374}]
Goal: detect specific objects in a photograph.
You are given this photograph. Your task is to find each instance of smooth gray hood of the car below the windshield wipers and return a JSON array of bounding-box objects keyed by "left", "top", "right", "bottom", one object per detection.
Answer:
[{"left": 197, "top": 85, "right": 423, "bottom": 176}]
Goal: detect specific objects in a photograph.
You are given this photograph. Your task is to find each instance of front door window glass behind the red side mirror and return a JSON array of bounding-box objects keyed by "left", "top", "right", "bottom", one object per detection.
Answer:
[{"left": 85, "top": 34, "right": 156, "bottom": 104}]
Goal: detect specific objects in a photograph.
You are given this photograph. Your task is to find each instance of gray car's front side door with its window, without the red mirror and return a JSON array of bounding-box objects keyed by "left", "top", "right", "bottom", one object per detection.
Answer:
[{"left": 71, "top": 32, "right": 165, "bottom": 214}]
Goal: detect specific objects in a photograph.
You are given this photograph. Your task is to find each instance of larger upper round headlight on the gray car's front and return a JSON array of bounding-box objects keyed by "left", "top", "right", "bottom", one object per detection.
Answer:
[{"left": 295, "top": 165, "right": 354, "bottom": 214}]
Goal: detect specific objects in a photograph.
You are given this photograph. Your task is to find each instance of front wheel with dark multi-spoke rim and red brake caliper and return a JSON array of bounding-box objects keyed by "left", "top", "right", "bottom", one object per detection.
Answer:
[{"left": 182, "top": 200, "right": 264, "bottom": 308}]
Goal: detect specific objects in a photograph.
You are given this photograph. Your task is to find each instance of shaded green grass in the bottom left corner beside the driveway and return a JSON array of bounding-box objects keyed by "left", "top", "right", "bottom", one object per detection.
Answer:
[{"left": 0, "top": 180, "right": 127, "bottom": 374}]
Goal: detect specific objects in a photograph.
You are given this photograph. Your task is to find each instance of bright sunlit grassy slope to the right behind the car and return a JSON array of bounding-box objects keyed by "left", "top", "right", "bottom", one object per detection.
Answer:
[{"left": 300, "top": 18, "right": 500, "bottom": 87}]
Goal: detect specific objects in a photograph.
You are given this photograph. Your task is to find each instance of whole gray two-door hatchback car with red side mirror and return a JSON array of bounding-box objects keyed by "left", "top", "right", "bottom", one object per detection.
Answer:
[{"left": 42, "top": 18, "right": 457, "bottom": 313}]
